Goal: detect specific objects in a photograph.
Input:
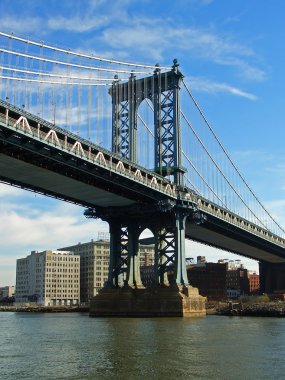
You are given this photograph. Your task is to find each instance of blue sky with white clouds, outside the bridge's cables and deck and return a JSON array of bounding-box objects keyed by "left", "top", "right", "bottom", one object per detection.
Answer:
[{"left": 0, "top": 0, "right": 285, "bottom": 286}]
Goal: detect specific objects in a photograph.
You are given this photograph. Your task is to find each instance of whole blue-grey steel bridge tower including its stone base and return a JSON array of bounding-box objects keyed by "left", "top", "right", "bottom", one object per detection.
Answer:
[{"left": 87, "top": 60, "right": 205, "bottom": 316}]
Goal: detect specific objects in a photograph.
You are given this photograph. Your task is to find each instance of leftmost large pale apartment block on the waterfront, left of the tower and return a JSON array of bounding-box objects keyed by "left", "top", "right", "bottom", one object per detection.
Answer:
[{"left": 15, "top": 250, "right": 80, "bottom": 306}]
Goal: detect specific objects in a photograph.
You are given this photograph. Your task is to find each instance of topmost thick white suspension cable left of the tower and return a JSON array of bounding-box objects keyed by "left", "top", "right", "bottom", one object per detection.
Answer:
[{"left": 0, "top": 32, "right": 171, "bottom": 70}]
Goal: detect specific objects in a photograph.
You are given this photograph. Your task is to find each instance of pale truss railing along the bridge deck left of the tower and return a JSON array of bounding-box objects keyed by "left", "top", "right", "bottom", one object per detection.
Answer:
[{"left": 0, "top": 101, "right": 176, "bottom": 199}]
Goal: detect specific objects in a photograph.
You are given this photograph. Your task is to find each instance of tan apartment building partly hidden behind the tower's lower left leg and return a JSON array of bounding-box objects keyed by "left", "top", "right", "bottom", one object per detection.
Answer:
[{"left": 60, "top": 239, "right": 154, "bottom": 303}]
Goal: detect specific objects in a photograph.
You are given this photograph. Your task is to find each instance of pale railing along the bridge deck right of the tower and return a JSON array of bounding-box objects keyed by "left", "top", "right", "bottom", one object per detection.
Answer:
[{"left": 183, "top": 194, "right": 285, "bottom": 248}]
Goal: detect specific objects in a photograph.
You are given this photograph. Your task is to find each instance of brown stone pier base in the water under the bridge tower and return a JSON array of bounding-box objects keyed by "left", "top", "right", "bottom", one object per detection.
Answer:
[{"left": 90, "top": 285, "right": 206, "bottom": 317}]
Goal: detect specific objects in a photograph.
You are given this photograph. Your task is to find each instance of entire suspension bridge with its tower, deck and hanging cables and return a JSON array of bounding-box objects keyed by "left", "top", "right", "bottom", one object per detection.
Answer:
[{"left": 0, "top": 32, "right": 285, "bottom": 315}]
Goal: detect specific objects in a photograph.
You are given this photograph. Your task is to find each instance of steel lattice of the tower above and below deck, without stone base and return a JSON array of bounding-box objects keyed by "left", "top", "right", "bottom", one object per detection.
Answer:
[{"left": 103, "top": 60, "right": 188, "bottom": 286}]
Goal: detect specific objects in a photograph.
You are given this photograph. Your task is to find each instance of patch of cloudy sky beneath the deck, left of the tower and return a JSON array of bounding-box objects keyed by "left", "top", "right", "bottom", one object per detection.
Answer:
[{"left": 0, "top": 185, "right": 108, "bottom": 286}]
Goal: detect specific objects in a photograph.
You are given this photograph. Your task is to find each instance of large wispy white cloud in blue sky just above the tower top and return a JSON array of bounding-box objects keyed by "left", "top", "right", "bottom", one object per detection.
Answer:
[{"left": 99, "top": 18, "right": 266, "bottom": 81}]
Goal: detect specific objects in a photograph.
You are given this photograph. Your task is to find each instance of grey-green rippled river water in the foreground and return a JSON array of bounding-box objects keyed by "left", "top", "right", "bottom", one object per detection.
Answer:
[{"left": 0, "top": 312, "right": 285, "bottom": 380}]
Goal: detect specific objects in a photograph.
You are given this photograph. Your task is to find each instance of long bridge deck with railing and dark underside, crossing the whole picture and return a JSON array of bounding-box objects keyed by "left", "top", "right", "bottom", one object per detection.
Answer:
[{"left": 0, "top": 101, "right": 285, "bottom": 263}]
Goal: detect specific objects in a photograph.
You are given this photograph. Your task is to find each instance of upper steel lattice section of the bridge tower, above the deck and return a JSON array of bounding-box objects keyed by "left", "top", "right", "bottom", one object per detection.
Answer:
[{"left": 110, "top": 60, "right": 184, "bottom": 184}]
